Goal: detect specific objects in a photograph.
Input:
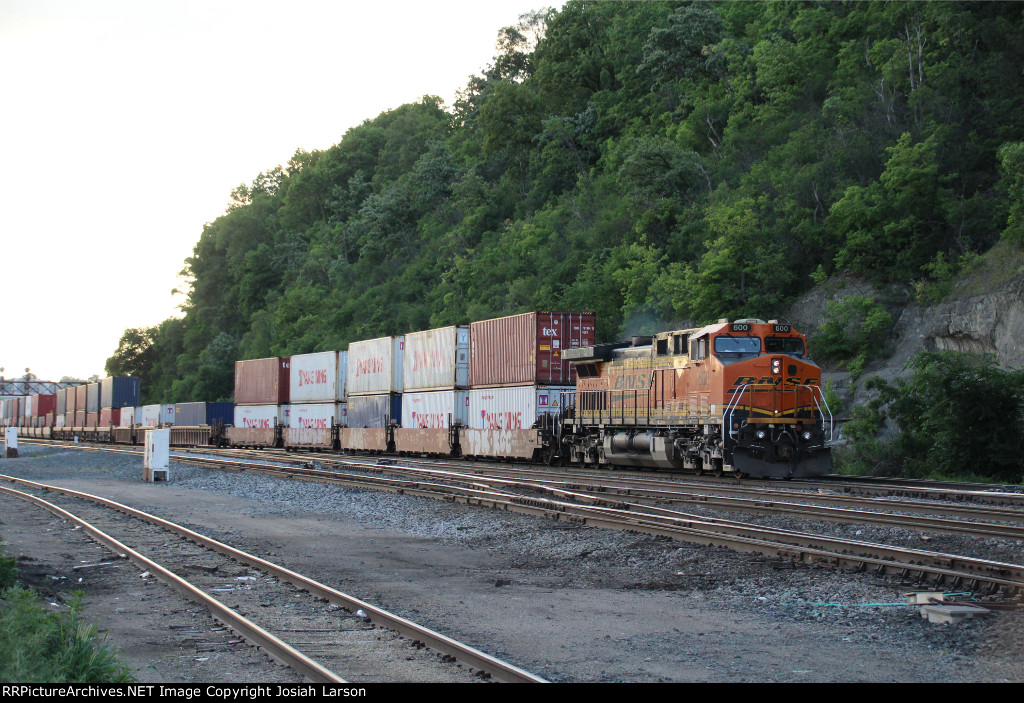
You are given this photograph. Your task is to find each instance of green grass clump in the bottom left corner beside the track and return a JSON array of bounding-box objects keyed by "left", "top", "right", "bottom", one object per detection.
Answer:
[{"left": 0, "top": 540, "right": 134, "bottom": 684}]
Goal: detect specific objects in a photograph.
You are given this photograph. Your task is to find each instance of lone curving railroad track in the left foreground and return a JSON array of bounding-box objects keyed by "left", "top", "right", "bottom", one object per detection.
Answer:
[{"left": 0, "top": 476, "right": 543, "bottom": 683}]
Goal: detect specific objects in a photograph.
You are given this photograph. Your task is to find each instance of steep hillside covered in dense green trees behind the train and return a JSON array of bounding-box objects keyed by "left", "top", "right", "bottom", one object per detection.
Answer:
[{"left": 106, "top": 2, "right": 1024, "bottom": 402}]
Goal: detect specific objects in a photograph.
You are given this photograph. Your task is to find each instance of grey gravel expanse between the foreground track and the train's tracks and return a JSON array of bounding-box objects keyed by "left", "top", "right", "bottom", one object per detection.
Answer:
[{"left": 0, "top": 444, "right": 1024, "bottom": 683}]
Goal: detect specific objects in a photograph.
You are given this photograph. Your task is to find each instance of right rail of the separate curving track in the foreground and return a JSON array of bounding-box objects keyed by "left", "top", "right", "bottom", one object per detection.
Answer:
[{"left": 0, "top": 467, "right": 546, "bottom": 683}]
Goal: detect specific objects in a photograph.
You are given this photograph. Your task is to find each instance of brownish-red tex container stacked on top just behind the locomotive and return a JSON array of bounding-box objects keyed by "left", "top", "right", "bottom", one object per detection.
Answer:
[{"left": 469, "top": 312, "right": 595, "bottom": 388}]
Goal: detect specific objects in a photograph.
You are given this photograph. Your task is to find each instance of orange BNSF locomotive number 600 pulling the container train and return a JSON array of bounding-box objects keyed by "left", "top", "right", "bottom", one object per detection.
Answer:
[{"left": 557, "top": 319, "right": 833, "bottom": 478}]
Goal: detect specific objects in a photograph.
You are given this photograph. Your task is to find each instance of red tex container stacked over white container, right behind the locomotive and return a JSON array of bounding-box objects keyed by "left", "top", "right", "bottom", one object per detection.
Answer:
[{"left": 461, "top": 312, "right": 595, "bottom": 458}]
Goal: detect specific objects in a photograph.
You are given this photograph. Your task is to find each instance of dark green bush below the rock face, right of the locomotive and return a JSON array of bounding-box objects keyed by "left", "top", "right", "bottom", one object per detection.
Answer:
[{"left": 846, "top": 351, "right": 1024, "bottom": 483}]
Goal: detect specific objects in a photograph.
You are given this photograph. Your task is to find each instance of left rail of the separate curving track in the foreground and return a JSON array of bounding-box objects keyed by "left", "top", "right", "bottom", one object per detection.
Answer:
[{"left": 0, "top": 476, "right": 348, "bottom": 684}]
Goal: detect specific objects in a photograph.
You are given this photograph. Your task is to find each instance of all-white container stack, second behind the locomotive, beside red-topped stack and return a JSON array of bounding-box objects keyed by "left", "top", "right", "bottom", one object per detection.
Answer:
[{"left": 394, "top": 325, "right": 469, "bottom": 454}]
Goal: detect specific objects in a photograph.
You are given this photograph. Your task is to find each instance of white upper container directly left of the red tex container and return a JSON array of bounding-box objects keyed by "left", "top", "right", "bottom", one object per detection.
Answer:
[{"left": 401, "top": 325, "right": 469, "bottom": 391}]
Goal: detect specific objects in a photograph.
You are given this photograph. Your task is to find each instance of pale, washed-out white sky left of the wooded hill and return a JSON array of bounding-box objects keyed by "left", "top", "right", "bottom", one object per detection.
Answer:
[{"left": 0, "top": 0, "right": 562, "bottom": 381}]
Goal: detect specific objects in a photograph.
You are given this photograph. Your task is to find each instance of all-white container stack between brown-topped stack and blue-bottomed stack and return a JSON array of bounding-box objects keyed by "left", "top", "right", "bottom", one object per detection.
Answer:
[{"left": 284, "top": 351, "right": 348, "bottom": 449}]
